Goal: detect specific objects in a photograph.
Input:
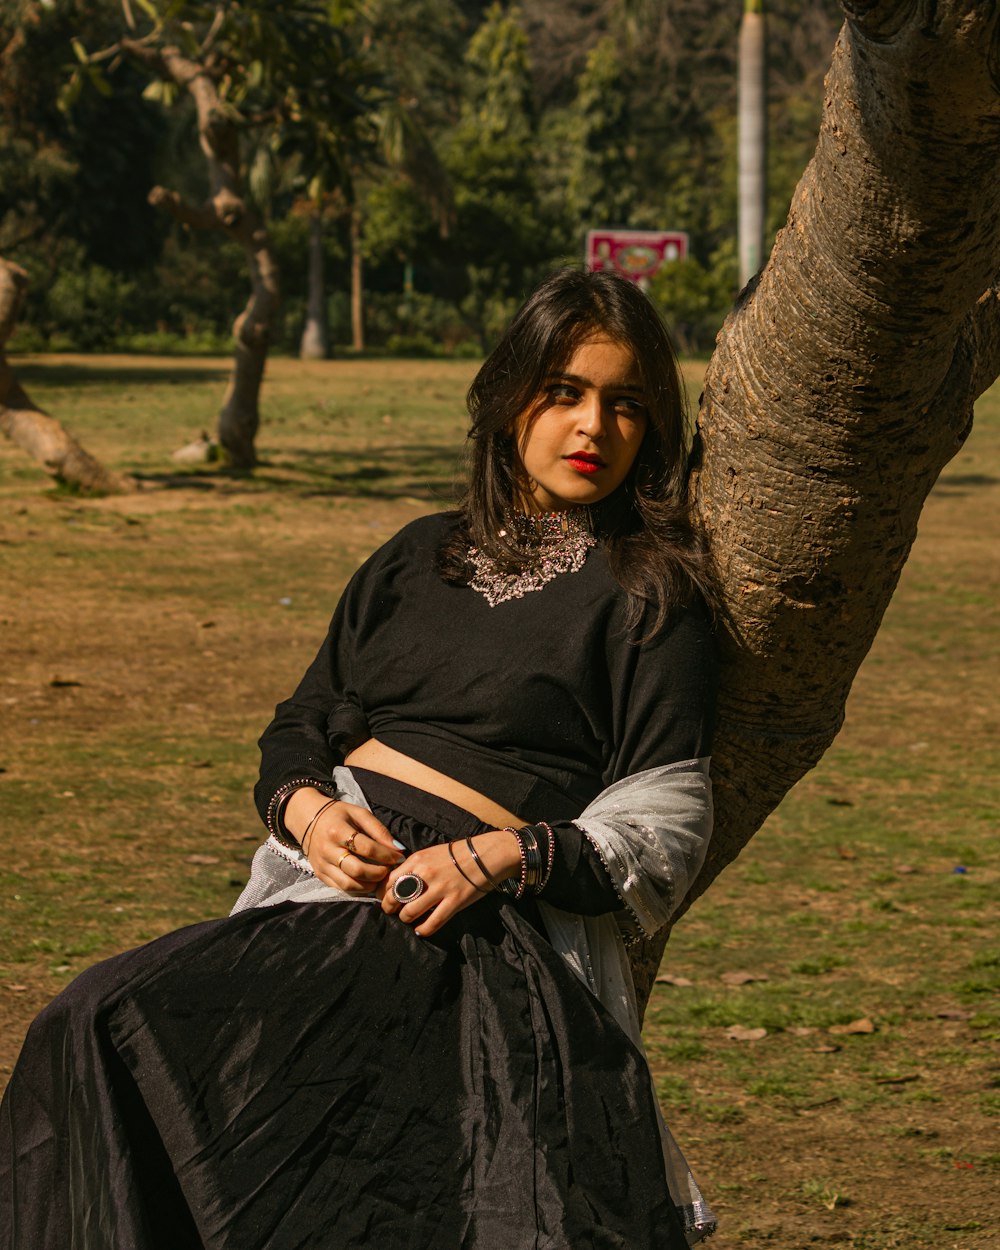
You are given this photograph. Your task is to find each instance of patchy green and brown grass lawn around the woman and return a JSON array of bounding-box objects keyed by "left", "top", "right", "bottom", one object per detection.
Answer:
[{"left": 0, "top": 358, "right": 1000, "bottom": 1250}]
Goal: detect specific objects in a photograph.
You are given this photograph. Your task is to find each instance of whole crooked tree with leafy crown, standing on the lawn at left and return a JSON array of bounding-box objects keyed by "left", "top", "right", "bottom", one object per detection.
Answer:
[{"left": 66, "top": 0, "right": 365, "bottom": 469}]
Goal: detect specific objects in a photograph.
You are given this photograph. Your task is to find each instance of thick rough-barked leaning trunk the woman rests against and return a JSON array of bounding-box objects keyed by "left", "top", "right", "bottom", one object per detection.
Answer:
[{"left": 636, "top": 0, "right": 1000, "bottom": 1010}]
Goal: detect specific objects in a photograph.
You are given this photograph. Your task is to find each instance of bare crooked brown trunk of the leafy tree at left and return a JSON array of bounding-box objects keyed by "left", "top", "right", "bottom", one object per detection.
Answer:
[{"left": 120, "top": 39, "right": 279, "bottom": 469}]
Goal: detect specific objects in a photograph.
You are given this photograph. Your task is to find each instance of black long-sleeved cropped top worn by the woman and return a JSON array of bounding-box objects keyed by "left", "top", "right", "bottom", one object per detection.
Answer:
[{"left": 255, "top": 513, "right": 718, "bottom": 910}]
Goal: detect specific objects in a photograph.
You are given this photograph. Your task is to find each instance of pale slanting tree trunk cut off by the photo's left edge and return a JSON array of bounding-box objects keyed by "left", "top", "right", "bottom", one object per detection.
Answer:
[{"left": 0, "top": 258, "right": 136, "bottom": 495}]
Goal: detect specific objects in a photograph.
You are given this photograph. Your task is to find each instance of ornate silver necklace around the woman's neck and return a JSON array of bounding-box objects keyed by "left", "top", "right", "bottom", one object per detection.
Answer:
[{"left": 469, "top": 508, "right": 598, "bottom": 608}]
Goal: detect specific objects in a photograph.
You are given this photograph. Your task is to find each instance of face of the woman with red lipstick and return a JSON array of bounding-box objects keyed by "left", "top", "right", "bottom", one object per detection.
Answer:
[{"left": 514, "top": 333, "right": 648, "bottom": 513}]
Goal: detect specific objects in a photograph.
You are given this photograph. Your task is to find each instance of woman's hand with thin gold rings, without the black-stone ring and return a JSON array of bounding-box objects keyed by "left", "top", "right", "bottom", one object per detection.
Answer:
[{"left": 284, "top": 786, "right": 406, "bottom": 894}]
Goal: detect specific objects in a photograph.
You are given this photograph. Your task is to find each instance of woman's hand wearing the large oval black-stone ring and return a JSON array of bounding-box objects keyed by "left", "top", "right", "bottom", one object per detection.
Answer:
[{"left": 376, "top": 829, "right": 521, "bottom": 938}]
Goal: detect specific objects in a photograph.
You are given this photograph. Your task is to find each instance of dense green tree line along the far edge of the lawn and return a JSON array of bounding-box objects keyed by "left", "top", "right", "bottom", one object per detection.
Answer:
[{"left": 0, "top": 0, "right": 840, "bottom": 354}]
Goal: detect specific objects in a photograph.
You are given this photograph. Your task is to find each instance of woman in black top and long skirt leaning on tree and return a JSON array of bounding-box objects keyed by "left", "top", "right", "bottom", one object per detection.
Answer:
[{"left": 0, "top": 271, "right": 715, "bottom": 1250}]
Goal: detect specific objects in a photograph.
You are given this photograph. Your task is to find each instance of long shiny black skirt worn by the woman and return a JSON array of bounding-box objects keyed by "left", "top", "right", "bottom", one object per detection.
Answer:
[{"left": 0, "top": 773, "right": 688, "bottom": 1250}]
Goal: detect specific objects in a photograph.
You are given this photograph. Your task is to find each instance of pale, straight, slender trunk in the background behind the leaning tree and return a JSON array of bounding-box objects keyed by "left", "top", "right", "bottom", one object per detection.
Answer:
[{"left": 739, "top": 0, "right": 768, "bottom": 286}]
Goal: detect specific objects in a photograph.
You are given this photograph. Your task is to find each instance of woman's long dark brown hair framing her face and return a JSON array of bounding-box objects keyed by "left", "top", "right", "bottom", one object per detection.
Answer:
[{"left": 439, "top": 269, "right": 708, "bottom": 633}]
